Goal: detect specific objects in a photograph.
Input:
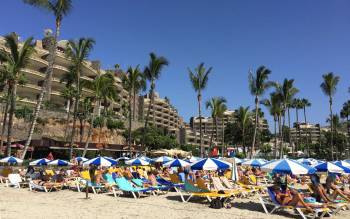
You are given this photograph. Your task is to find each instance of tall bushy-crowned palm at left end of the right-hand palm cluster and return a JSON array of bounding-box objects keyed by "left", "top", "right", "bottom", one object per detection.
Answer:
[{"left": 248, "top": 66, "right": 272, "bottom": 158}]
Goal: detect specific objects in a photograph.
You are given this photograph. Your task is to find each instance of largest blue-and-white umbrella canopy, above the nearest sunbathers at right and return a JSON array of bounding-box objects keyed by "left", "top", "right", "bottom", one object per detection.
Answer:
[{"left": 261, "top": 159, "right": 315, "bottom": 175}]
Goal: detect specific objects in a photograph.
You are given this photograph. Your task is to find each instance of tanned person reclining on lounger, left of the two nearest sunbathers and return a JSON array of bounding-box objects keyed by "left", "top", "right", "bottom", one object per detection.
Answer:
[{"left": 272, "top": 186, "right": 326, "bottom": 211}]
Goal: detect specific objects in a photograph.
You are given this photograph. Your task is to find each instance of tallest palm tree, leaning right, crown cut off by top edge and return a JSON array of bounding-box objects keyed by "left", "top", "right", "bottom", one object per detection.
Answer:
[{"left": 22, "top": 0, "right": 72, "bottom": 159}]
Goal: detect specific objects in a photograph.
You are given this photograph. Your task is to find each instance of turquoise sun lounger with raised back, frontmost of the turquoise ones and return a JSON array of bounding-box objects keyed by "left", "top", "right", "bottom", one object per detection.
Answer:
[{"left": 112, "top": 177, "right": 154, "bottom": 199}]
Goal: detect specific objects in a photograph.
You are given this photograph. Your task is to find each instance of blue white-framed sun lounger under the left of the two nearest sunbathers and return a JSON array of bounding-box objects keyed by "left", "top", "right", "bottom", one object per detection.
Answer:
[{"left": 259, "top": 188, "right": 332, "bottom": 219}]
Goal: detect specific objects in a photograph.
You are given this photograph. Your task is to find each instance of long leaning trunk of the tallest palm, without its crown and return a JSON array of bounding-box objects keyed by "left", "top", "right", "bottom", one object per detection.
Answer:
[{"left": 21, "top": 21, "right": 61, "bottom": 159}]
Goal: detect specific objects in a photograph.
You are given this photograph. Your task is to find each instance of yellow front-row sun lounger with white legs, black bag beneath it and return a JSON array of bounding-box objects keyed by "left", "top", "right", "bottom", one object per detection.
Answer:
[{"left": 177, "top": 181, "right": 232, "bottom": 202}]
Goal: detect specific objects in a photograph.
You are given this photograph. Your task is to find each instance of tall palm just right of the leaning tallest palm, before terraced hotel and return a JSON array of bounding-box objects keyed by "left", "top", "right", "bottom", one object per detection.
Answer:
[{"left": 66, "top": 38, "right": 95, "bottom": 159}]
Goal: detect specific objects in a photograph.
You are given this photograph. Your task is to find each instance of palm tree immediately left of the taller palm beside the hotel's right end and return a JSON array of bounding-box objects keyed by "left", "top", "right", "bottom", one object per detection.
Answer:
[{"left": 122, "top": 65, "right": 146, "bottom": 156}]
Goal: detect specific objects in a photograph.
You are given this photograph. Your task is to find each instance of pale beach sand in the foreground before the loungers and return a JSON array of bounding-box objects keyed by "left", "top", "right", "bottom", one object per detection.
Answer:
[{"left": 0, "top": 185, "right": 349, "bottom": 219}]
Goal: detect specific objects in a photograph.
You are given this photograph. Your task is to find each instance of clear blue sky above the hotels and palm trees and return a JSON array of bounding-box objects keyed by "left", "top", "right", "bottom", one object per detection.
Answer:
[{"left": 0, "top": 0, "right": 350, "bottom": 128}]
